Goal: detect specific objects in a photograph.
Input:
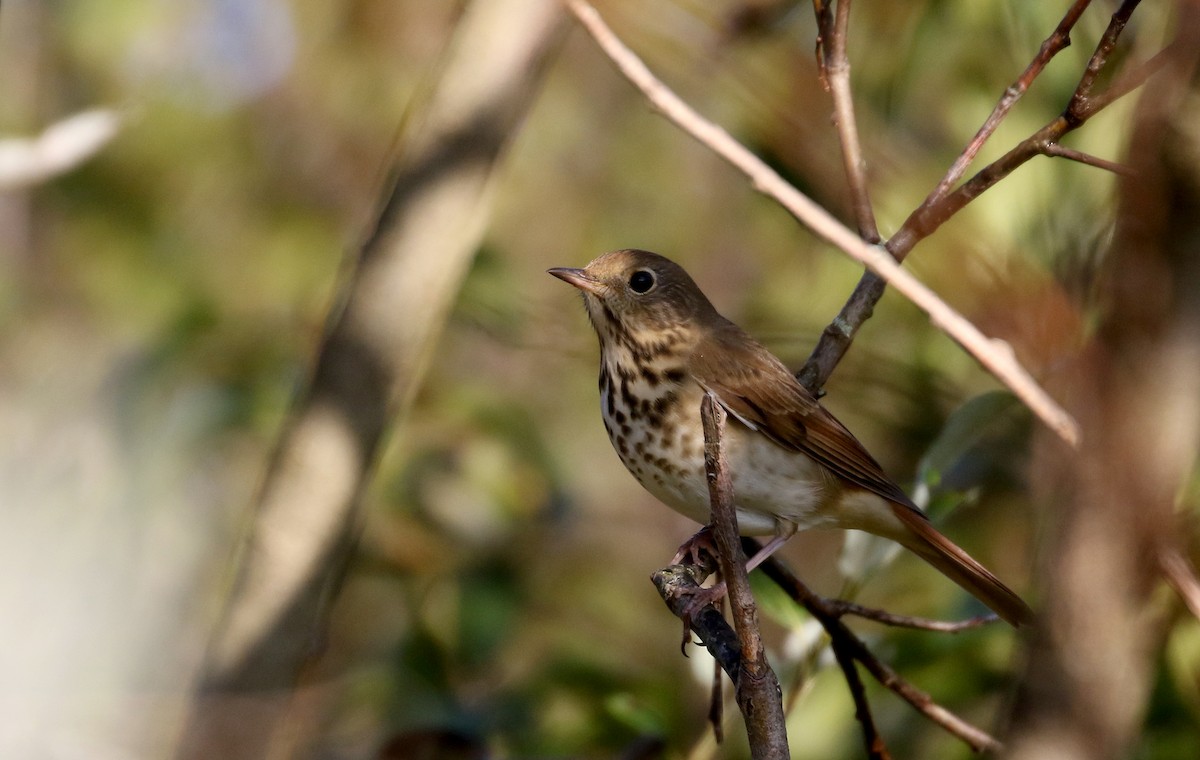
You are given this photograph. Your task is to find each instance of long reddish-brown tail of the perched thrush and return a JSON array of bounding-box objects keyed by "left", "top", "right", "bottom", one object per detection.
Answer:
[{"left": 889, "top": 502, "right": 1033, "bottom": 628}]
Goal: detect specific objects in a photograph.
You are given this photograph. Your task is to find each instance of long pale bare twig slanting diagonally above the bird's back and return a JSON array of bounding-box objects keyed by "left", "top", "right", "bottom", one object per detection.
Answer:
[{"left": 565, "top": 0, "right": 1079, "bottom": 445}]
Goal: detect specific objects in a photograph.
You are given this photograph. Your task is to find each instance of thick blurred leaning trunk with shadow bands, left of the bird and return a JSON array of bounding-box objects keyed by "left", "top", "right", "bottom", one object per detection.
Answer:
[{"left": 179, "top": 0, "right": 563, "bottom": 760}]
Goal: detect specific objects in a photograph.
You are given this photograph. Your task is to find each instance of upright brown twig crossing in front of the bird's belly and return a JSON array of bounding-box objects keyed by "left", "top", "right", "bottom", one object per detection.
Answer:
[{"left": 700, "top": 393, "right": 791, "bottom": 760}]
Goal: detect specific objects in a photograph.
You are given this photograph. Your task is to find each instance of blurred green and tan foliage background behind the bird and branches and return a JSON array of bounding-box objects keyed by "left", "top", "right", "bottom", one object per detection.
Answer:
[{"left": 0, "top": 0, "right": 1200, "bottom": 759}]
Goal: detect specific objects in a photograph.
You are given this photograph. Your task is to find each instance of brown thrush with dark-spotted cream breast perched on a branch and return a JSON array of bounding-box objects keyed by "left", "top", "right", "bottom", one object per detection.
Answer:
[{"left": 547, "top": 249, "right": 1033, "bottom": 627}]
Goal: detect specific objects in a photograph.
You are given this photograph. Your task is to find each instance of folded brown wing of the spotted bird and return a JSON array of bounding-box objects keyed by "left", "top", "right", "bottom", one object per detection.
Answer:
[{"left": 689, "top": 322, "right": 916, "bottom": 509}]
